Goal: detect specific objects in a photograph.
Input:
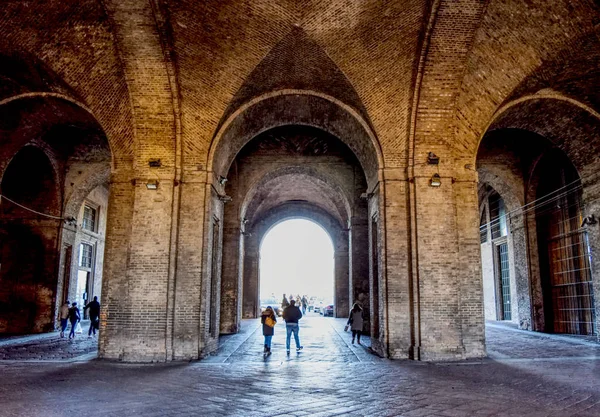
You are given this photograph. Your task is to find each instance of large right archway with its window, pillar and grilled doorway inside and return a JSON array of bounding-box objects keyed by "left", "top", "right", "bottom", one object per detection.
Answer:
[{"left": 477, "top": 99, "right": 598, "bottom": 335}]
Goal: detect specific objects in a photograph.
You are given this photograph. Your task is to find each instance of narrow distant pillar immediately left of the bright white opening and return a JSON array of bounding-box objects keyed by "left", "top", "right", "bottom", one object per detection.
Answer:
[{"left": 242, "top": 232, "right": 260, "bottom": 319}]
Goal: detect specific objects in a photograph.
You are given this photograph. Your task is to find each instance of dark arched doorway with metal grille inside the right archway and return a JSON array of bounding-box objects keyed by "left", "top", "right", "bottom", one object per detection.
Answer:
[{"left": 531, "top": 149, "right": 597, "bottom": 335}]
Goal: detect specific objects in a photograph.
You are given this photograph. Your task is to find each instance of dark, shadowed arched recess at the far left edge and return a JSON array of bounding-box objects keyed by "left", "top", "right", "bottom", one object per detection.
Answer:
[{"left": 0, "top": 146, "right": 61, "bottom": 333}]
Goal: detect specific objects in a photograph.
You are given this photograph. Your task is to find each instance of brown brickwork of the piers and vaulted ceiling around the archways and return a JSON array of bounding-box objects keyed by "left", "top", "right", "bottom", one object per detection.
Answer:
[{"left": 0, "top": 0, "right": 600, "bottom": 361}]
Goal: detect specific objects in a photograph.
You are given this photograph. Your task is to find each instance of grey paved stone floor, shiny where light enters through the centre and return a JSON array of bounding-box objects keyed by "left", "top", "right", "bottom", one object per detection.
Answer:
[{"left": 0, "top": 317, "right": 600, "bottom": 417}]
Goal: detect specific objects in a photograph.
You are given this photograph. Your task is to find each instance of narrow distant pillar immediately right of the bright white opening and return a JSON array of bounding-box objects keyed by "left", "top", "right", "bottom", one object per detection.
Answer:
[{"left": 332, "top": 230, "right": 350, "bottom": 317}]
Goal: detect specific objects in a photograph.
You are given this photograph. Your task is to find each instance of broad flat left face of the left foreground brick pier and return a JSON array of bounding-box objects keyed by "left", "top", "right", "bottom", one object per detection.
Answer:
[{"left": 99, "top": 168, "right": 174, "bottom": 362}]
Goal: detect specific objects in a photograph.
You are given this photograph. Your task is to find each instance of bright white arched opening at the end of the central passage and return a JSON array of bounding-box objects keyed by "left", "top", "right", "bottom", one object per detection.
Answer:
[{"left": 259, "top": 219, "right": 334, "bottom": 305}]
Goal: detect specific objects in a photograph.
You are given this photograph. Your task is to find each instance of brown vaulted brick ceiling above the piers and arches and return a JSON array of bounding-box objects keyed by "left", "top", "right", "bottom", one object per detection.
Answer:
[{"left": 0, "top": 0, "right": 600, "bottom": 169}]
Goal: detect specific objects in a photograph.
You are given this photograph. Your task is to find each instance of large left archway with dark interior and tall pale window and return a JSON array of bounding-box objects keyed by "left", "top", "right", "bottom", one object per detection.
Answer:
[{"left": 0, "top": 94, "right": 112, "bottom": 334}]
